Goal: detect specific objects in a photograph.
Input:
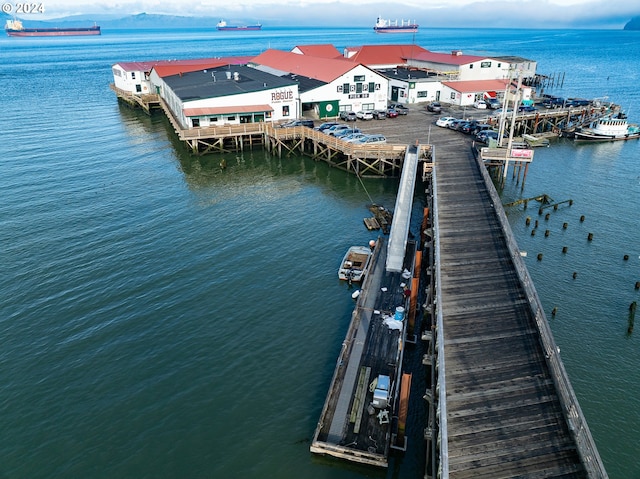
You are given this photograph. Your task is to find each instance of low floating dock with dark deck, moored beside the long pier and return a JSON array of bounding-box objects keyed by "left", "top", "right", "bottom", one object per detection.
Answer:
[{"left": 311, "top": 238, "right": 416, "bottom": 467}]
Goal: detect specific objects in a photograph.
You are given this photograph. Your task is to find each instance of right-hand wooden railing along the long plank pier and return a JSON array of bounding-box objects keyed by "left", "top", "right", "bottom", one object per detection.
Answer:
[{"left": 478, "top": 155, "right": 609, "bottom": 479}]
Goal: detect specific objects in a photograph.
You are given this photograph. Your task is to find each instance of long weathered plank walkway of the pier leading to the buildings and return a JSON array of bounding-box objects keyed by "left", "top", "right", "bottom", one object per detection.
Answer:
[{"left": 433, "top": 141, "right": 607, "bottom": 479}]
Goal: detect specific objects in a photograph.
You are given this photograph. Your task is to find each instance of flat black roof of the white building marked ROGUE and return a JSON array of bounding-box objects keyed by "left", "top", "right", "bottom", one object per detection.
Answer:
[{"left": 164, "top": 65, "right": 296, "bottom": 101}]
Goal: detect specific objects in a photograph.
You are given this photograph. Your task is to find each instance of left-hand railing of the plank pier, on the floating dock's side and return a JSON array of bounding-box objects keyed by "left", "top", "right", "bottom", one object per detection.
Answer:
[{"left": 431, "top": 145, "right": 449, "bottom": 479}]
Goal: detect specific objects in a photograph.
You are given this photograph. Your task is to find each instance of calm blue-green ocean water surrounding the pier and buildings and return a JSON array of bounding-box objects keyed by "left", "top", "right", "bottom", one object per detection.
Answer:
[{"left": 0, "top": 28, "right": 640, "bottom": 479}]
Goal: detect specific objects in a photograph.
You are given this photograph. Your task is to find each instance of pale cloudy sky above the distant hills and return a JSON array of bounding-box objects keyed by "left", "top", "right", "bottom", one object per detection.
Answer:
[{"left": 11, "top": 0, "right": 640, "bottom": 29}]
